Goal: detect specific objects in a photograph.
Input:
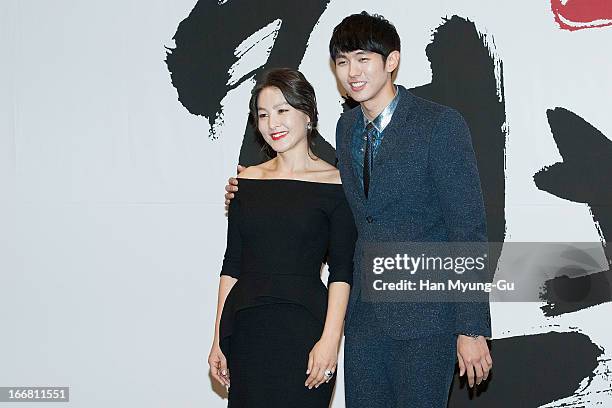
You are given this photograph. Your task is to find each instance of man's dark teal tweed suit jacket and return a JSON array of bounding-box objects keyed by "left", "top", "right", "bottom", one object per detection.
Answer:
[{"left": 336, "top": 85, "right": 491, "bottom": 339}]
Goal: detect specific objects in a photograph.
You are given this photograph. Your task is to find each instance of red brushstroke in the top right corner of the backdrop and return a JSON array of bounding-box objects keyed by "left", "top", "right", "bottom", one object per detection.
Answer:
[{"left": 550, "top": 0, "right": 612, "bottom": 31}]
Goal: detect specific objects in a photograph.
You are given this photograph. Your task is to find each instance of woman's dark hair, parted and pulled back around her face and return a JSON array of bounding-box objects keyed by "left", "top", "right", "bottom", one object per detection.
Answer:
[{"left": 249, "top": 68, "right": 319, "bottom": 157}]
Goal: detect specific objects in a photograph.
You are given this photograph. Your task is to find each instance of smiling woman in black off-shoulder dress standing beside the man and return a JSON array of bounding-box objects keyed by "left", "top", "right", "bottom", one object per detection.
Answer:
[{"left": 209, "top": 69, "right": 357, "bottom": 408}]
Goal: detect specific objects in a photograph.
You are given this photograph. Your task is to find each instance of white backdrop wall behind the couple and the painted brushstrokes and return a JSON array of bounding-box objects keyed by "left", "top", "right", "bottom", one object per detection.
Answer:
[{"left": 0, "top": 0, "right": 612, "bottom": 408}]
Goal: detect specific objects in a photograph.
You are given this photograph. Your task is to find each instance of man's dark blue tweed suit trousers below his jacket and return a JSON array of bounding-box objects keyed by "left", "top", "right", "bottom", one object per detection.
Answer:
[{"left": 344, "top": 300, "right": 457, "bottom": 408}]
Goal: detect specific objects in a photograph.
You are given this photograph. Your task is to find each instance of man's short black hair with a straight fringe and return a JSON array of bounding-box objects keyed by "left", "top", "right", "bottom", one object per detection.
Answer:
[{"left": 329, "top": 11, "right": 400, "bottom": 62}]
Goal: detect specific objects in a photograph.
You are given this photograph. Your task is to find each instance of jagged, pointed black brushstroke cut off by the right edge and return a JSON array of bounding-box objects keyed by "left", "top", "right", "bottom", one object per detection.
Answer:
[{"left": 534, "top": 108, "right": 612, "bottom": 316}]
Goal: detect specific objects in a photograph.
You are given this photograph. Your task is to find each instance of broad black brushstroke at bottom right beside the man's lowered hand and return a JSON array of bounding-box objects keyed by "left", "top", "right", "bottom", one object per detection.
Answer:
[{"left": 448, "top": 332, "right": 603, "bottom": 408}]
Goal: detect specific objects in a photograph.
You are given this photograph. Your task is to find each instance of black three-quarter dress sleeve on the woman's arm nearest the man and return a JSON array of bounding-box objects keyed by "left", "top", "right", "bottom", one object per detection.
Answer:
[{"left": 327, "top": 193, "right": 357, "bottom": 285}]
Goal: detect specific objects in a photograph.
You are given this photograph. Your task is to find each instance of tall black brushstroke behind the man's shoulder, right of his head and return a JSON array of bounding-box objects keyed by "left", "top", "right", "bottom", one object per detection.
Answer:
[{"left": 412, "top": 16, "right": 506, "bottom": 252}]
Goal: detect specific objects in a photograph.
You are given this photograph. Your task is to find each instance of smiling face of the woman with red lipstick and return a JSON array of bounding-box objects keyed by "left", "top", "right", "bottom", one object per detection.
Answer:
[{"left": 257, "top": 86, "right": 310, "bottom": 153}]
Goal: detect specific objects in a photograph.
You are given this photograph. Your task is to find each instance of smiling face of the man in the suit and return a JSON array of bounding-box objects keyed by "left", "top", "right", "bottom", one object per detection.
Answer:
[{"left": 335, "top": 50, "right": 391, "bottom": 103}]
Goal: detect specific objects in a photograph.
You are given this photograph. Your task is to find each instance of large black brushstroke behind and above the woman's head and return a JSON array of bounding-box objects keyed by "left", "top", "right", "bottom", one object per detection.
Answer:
[{"left": 166, "top": 0, "right": 335, "bottom": 165}]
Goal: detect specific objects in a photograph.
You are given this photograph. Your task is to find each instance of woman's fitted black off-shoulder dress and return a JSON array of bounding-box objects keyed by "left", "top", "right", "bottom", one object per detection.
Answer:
[{"left": 220, "top": 179, "right": 357, "bottom": 408}]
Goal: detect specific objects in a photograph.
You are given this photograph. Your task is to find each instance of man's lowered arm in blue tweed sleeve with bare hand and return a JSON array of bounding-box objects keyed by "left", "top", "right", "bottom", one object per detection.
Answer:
[{"left": 430, "top": 109, "right": 493, "bottom": 387}]
